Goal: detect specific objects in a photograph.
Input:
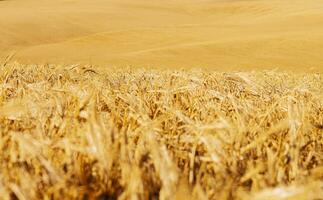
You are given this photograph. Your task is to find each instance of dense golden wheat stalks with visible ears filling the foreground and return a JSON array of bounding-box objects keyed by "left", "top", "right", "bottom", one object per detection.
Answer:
[{"left": 0, "top": 63, "right": 323, "bottom": 200}]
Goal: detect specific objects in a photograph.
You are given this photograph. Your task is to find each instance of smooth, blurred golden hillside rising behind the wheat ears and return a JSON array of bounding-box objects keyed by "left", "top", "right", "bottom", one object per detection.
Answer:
[{"left": 0, "top": 0, "right": 323, "bottom": 72}]
